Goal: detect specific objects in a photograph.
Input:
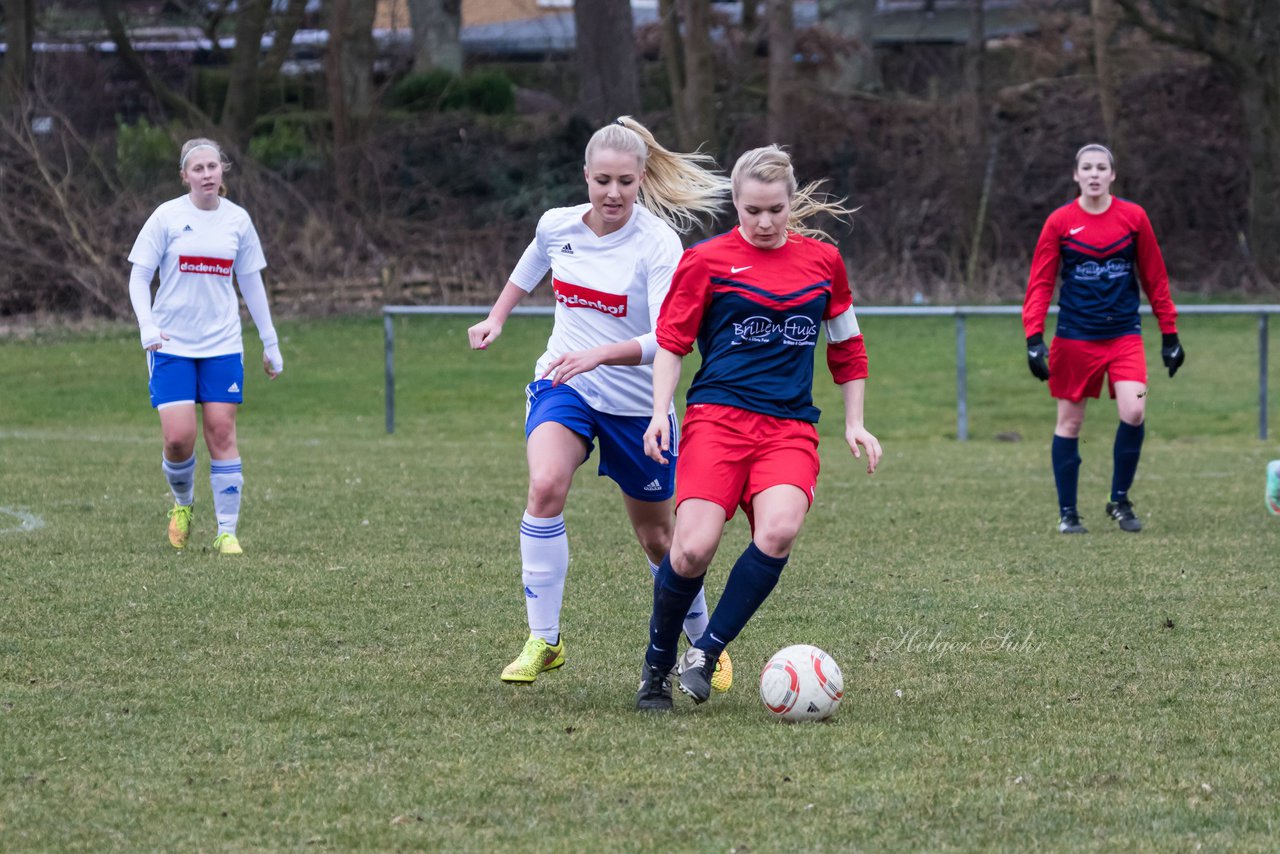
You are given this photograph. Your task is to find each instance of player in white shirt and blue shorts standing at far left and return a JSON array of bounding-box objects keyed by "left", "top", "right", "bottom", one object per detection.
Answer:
[{"left": 129, "top": 140, "right": 284, "bottom": 554}]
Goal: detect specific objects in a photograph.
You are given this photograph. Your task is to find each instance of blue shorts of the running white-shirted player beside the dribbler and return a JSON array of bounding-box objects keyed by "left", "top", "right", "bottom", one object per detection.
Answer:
[{"left": 525, "top": 379, "right": 680, "bottom": 501}]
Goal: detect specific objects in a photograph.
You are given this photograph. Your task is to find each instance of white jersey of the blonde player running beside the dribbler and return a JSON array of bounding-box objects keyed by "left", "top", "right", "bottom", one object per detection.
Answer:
[{"left": 511, "top": 204, "right": 684, "bottom": 416}]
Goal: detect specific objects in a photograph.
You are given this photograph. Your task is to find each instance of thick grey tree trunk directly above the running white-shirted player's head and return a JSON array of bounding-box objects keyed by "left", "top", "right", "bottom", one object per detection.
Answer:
[{"left": 573, "top": 0, "right": 640, "bottom": 122}]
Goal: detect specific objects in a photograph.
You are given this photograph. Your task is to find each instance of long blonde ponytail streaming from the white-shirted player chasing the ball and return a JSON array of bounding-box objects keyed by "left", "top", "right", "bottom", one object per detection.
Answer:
[{"left": 585, "top": 115, "right": 731, "bottom": 234}]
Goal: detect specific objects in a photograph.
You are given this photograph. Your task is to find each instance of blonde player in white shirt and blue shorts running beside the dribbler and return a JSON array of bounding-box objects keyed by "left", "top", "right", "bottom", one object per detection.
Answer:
[{"left": 467, "top": 117, "right": 732, "bottom": 690}]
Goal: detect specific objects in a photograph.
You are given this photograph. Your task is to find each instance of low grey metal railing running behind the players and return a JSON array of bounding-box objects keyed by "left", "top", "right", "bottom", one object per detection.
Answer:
[{"left": 383, "top": 305, "right": 1280, "bottom": 442}]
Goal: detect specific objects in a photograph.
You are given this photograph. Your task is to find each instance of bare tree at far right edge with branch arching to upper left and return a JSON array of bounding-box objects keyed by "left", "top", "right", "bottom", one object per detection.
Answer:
[{"left": 1116, "top": 0, "right": 1280, "bottom": 280}]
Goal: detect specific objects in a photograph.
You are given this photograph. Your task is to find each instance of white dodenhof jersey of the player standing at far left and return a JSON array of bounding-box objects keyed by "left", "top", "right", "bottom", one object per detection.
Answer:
[{"left": 129, "top": 196, "right": 266, "bottom": 359}]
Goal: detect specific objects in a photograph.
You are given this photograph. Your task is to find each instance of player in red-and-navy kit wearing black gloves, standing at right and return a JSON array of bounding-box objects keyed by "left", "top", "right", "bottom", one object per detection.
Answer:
[{"left": 1023, "top": 143, "right": 1187, "bottom": 534}]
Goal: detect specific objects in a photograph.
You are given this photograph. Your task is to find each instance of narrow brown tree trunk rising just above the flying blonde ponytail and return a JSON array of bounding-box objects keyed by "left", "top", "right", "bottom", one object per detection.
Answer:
[{"left": 658, "top": 0, "right": 716, "bottom": 151}]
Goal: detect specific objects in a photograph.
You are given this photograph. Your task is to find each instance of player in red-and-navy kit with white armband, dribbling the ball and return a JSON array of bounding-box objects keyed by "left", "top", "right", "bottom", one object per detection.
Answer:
[{"left": 636, "top": 146, "right": 881, "bottom": 711}]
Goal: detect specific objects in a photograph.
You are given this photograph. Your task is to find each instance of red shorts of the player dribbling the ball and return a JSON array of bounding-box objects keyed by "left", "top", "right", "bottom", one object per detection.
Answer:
[{"left": 676, "top": 403, "right": 819, "bottom": 520}]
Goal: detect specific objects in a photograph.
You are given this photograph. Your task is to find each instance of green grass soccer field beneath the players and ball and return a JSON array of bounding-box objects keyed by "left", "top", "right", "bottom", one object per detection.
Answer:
[{"left": 0, "top": 318, "right": 1280, "bottom": 853}]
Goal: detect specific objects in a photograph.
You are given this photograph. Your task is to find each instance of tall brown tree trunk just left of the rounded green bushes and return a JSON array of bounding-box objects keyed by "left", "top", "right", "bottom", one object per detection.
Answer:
[{"left": 325, "top": 0, "right": 378, "bottom": 204}]
